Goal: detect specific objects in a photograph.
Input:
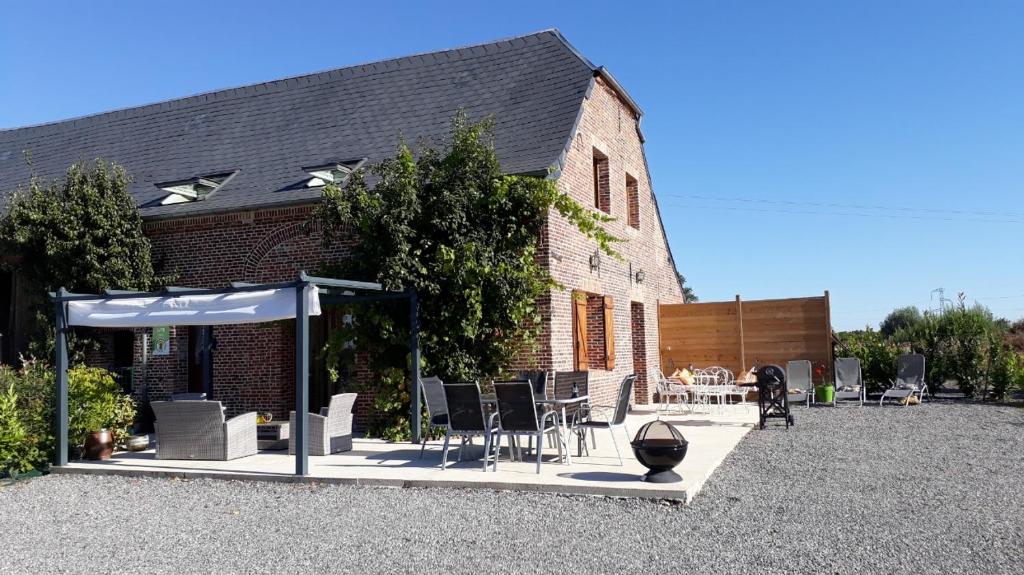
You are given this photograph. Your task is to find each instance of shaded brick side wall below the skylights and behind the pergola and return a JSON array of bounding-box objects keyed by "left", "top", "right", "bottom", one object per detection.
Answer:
[{"left": 130, "top": 206, "right": 347, "bottom": 417}]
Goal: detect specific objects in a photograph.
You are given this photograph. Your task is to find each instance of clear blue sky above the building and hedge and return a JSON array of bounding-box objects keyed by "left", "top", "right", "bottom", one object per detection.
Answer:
[{"left": 0, "top": 0, "right": 1024, "bottom": 329}]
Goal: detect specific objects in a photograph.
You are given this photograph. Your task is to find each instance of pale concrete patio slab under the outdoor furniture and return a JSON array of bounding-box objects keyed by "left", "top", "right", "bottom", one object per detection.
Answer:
[{"left": 52, "top": 404, "right": 757, "bottom": 502}]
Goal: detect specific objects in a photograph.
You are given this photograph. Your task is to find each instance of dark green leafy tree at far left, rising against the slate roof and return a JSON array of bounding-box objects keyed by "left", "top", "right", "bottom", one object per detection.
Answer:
[{"left": 0, "top": 160, "right": 156, "bottom": 353}]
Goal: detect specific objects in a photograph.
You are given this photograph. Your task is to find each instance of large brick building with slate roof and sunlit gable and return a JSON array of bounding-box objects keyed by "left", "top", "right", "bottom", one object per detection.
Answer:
[{"left": 6, "top": 31, "right": 682, "bottom": 416}]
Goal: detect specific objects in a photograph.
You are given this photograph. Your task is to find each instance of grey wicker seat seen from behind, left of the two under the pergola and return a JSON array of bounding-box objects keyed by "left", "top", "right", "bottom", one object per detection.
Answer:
[{"left": 151, "top": 400, "right": 256, "bottom": 461}]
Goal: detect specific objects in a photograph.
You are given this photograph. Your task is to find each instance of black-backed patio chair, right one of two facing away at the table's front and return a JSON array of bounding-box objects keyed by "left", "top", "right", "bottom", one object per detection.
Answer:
[{"left": 484, "top": 382, "right": 568, "bottom": 473}]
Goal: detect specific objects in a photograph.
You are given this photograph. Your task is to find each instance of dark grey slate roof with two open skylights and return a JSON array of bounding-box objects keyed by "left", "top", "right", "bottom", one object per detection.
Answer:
[{"left": 0, "top": 30, "right": 606, "bottom": 219}]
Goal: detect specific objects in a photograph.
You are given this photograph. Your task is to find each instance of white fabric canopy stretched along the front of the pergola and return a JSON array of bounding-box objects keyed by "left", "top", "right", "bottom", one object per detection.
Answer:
[{"left": 68, "top": 285, "right": 321, "bottom": 327}]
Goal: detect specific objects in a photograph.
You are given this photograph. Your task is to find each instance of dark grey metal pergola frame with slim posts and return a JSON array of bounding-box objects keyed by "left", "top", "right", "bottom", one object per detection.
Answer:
[{"left": 49, "top": 271, "right": 421, "bottom": 476}]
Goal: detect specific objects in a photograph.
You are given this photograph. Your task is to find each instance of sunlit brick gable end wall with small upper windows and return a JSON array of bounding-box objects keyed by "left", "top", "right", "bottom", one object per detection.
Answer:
[{"left": 546, "top": 78, "right": 682, "bottom": 403}]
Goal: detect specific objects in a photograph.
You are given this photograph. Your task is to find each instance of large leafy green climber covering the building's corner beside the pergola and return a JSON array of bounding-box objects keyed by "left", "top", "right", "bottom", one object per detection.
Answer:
[{"left": 313, "top": 114, "right": 620, "bottom": 439}]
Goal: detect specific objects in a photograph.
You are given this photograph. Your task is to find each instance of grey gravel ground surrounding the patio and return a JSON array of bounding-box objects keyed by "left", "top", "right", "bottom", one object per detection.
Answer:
[{"left": 0, "top": 403, "right": 1024, "bottom": 574}]
